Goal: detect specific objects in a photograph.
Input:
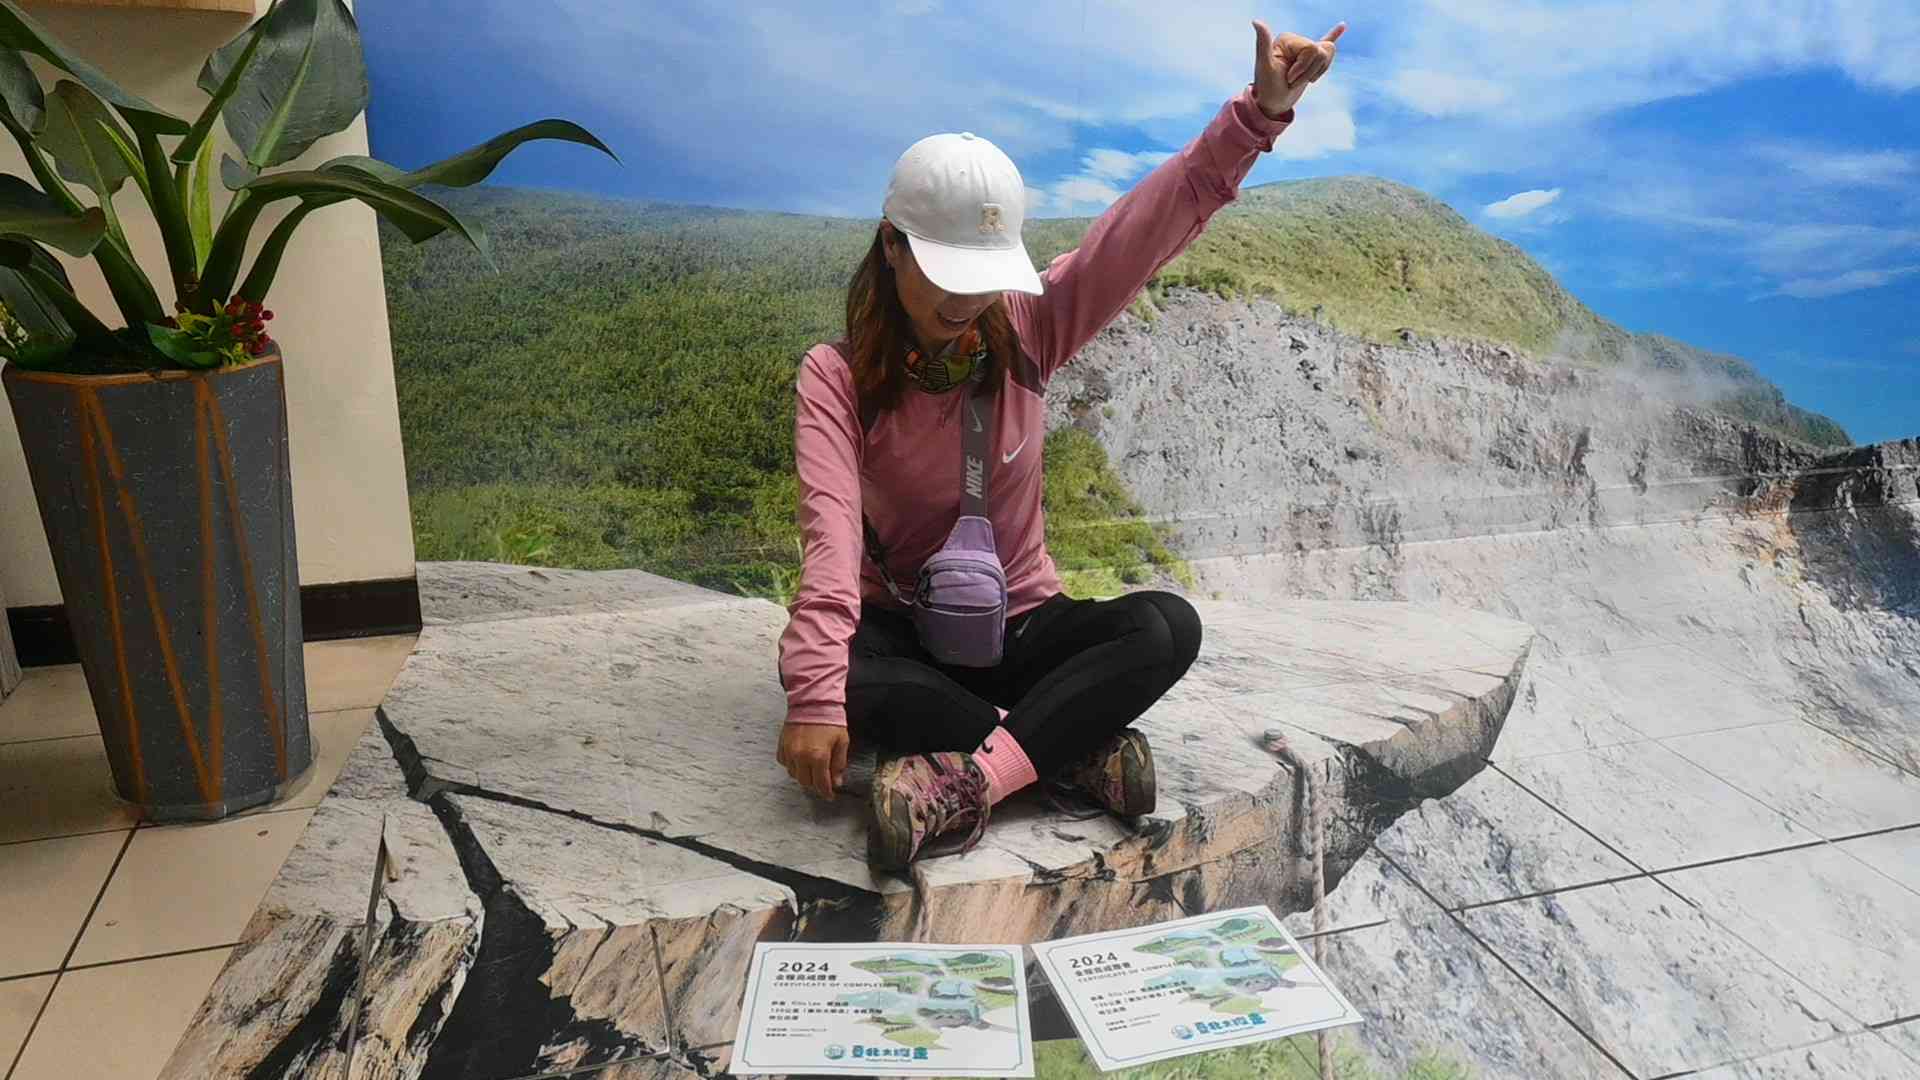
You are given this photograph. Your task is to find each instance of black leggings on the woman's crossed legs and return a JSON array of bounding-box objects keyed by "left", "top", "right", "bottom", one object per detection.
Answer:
[{"left": 847, "top": 592, "right": 1200, "bottom": 776}]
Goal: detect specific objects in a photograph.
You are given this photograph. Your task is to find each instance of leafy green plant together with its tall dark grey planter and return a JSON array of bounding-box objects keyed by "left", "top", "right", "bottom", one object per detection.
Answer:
[{"left": 0, "top": 0, "right": 611, "bottom": 819}]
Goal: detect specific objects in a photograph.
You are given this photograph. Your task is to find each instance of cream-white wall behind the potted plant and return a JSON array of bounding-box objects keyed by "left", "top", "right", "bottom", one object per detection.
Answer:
[{"left": 0, "top": 4, "right": 413, "bottom": 605}]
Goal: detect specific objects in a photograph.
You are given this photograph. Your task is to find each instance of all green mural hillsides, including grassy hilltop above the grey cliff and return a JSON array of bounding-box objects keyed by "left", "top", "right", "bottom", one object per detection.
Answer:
[{"left": 382, "top": 179, "right": 1845, "bottom": 596}]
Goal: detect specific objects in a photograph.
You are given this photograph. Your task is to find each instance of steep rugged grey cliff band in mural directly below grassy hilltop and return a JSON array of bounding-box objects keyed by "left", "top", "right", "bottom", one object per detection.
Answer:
[{"left": 1052, "top": 292, "right": 1818, "bottom": 559}]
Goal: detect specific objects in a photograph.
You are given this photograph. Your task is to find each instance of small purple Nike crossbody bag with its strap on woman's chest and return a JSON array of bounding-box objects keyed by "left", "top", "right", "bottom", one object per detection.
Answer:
[{"left": 866, "top": 384, "right": 1006, "bottom": 667}]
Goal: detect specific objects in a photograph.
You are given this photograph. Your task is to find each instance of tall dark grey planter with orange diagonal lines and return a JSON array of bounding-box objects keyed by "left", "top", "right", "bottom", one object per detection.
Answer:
[{"left": 0, "top": 356, "right": 313, "bottom": 819}]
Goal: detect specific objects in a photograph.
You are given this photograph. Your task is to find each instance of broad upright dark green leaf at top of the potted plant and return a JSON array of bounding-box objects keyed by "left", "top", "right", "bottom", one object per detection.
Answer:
[{"left": 206, "top": 0, "right": 369, "bottom": 169}]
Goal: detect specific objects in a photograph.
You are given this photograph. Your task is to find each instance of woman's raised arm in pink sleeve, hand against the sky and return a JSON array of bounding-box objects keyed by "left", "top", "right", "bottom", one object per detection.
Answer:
[{"left": 1010, "top": 23, "right": 1346, "bottom": 379}]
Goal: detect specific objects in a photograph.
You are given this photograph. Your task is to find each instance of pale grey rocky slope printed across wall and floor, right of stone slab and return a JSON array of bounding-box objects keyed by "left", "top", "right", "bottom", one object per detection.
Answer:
[{"left": 1052, "top": 292, "right": 1920, "bottom": 1078}]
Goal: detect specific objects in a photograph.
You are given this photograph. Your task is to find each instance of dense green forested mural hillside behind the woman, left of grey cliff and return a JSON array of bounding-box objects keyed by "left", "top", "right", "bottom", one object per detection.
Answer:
[{"left": 382, "top": 188, "right": 1179, "bottom": 596}]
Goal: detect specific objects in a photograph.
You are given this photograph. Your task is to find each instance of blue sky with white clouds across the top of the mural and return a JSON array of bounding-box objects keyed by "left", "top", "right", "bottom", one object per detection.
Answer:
[{"left": 456, "top": 0, "right": 1920, "bottom": 307}]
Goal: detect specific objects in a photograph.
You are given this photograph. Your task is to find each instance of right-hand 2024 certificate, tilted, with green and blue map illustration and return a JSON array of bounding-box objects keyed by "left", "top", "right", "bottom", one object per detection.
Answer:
[{"left": 1033, "top": 907, "right": 1361, "bottom": 1070}]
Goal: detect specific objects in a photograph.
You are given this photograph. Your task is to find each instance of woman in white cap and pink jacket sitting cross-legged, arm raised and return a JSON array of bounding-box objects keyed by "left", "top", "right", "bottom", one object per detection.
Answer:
[{"left": 780, "top": 23, "right": 1346, "bottom": 871}]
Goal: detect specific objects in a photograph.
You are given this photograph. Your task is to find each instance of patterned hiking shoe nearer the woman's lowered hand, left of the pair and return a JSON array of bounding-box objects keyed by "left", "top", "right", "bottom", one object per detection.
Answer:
[{"left": 866, "top": 751, "right": 987, "bottom": 871}]
